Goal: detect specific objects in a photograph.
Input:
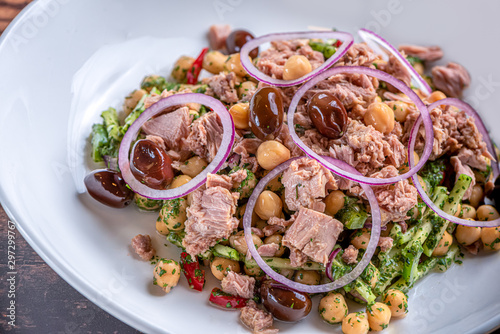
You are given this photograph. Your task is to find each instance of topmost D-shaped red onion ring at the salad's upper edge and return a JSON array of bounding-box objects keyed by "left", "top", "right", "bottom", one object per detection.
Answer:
[{"left": 240, "top": 31, "right": 354, "bottom": 87}]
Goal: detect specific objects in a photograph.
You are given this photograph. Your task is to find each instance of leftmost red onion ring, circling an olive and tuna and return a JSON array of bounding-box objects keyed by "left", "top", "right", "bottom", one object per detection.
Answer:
[{"left": 118, "top": 93, "right": 235, "bottom": 200}]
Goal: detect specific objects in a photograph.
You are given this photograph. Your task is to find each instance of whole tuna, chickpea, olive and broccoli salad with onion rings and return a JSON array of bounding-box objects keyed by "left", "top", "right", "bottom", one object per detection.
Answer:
[{"left": 85, "top": 25, "right": 500, "bottom": 333}]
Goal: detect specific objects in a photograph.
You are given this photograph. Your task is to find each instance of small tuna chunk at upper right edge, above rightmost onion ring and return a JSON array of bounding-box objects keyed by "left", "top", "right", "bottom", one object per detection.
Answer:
[{"left": 432, "top": 63, "right": 470, "bottom": 97}]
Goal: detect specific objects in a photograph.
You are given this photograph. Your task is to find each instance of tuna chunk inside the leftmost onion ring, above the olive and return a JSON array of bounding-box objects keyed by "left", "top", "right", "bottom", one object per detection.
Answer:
[{"left": 142, "top": 107, "right": 192, "bottom": 151}]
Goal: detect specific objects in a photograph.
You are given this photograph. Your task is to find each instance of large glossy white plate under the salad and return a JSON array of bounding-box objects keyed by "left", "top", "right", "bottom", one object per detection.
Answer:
[{"left": 0, "top": 0, "right": 500, "bottom": 334}]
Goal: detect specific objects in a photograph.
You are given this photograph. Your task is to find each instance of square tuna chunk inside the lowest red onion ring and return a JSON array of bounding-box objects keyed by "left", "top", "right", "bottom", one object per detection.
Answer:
[{"left": 283, "top": 208, "right": 343, "bottom": 265}]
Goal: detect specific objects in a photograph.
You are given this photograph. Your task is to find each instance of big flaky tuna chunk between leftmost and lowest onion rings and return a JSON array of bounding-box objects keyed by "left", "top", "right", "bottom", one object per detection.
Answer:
[{"left": 182, "top": 186, "right": 239, "bottom": 256}]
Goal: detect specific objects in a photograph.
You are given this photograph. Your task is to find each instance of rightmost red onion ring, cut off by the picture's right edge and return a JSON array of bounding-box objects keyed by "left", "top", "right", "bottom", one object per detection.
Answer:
[{"left": 408, "top": 98, "right": 500, "bottom": 227}]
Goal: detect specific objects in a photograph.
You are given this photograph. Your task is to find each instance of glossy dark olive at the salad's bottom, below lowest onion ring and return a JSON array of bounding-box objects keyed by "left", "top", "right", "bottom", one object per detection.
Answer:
[{"left": 260, "top": 280, "right": 312, "bottom": 322}]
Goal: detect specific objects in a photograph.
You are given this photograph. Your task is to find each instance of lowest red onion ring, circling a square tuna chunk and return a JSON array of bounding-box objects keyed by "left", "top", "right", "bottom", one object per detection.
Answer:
[{"left": 243, "top": 157, "right": 381, "bottom": 293}]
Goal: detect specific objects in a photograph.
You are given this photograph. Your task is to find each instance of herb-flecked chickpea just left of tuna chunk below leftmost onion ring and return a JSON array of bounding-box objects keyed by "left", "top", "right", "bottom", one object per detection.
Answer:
[{"left": 156, "top": 198, "right": 187, "bottom": 235}]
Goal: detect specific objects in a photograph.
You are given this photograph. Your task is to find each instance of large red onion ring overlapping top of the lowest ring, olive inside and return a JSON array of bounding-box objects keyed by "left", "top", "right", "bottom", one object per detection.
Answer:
[{"left": 287, "top": 66, "right": 434, "bottom": 185}]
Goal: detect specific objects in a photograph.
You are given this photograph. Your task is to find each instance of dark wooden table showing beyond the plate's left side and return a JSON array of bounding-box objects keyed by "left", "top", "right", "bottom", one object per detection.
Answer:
[{"left": 0, "top": 0, "right": 140, "bottom": 334}]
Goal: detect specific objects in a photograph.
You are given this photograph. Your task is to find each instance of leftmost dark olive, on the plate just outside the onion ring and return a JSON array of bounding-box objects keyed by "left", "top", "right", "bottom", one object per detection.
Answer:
[{"left": 84, "top": 169, "right": 134, "bottom": 208}]
